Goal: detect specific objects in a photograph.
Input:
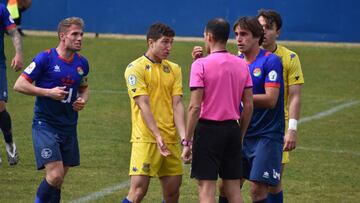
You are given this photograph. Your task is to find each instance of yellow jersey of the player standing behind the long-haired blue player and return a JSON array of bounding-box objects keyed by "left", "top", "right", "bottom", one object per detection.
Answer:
[{"left": 274, "top": 45, "right": 304, "bottom": 120}]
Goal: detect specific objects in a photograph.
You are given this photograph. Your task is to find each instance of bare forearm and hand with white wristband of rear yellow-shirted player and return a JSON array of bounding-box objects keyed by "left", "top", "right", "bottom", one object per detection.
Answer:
[{"left": 284, "top": 85, "right": 301, "bottom": 151}]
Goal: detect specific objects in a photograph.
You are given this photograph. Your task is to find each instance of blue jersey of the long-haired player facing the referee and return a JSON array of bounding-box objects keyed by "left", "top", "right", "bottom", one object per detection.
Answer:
[{"left": 240, "top": 49, "right": 285, "bottom": 142}]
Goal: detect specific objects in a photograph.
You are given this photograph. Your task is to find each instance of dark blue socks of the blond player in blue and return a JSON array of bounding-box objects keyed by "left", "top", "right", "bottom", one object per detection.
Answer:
[{"left": 35, "top": 179, "right": 61, "bottom": 203}]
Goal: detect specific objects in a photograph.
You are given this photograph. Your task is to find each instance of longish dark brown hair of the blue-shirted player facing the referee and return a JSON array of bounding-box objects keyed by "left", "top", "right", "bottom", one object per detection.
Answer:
[{"left": 233, "top": 16, "right": 264, "bottom": 45}]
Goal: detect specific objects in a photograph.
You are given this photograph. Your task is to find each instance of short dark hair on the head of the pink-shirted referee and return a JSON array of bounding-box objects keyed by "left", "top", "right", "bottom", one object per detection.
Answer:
[{"left": 205, "top": 18, "right": 230, "bottom": 43}]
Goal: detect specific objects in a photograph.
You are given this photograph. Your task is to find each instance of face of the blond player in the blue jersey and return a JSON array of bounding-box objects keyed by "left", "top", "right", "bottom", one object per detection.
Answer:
[{"left": 60, "top": 25, "right": 84, "bottom": 52}]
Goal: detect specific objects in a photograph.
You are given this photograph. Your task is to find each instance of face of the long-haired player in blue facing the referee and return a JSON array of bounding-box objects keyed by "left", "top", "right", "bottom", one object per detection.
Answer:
[{"left": 235, "top": 26, "right": 259, "bottom": 53}]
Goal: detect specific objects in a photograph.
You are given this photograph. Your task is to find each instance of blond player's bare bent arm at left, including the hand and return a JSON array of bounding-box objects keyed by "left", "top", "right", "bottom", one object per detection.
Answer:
[{"left": 14, "top": 75, "right": 69, "bottom": 101}]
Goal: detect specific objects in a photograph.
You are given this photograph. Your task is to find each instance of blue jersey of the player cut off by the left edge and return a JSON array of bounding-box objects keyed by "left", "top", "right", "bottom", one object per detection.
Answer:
[{"left": 0, "top": 3, "right": 16, "bottom": 62}]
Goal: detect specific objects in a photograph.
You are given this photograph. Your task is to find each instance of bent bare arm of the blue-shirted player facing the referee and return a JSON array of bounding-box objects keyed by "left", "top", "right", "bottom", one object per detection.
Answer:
[{"left": 254, "top": 87, "right": 280, "bottom": 109}]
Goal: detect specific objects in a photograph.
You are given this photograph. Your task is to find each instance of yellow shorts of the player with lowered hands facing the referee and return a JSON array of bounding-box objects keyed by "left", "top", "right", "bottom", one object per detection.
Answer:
[{"left": 129, "top": 142, "right": 183, "bottom": 177}]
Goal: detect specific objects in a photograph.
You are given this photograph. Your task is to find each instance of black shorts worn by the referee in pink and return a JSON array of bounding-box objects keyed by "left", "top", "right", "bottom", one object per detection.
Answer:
[{"left": 191, "top": 119, "right": 242, "bottom": 180}]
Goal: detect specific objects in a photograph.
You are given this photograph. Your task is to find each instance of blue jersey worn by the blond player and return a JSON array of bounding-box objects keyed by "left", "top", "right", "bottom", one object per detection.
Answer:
[{"left": 22, "top": 48, "right": 89, "bottom": 132}]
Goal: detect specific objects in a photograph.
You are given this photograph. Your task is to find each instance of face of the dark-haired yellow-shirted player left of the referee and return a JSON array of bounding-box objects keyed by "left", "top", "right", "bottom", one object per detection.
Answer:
[{"left": 150, "top": 36, "right": 174, "bottom": 61}]
